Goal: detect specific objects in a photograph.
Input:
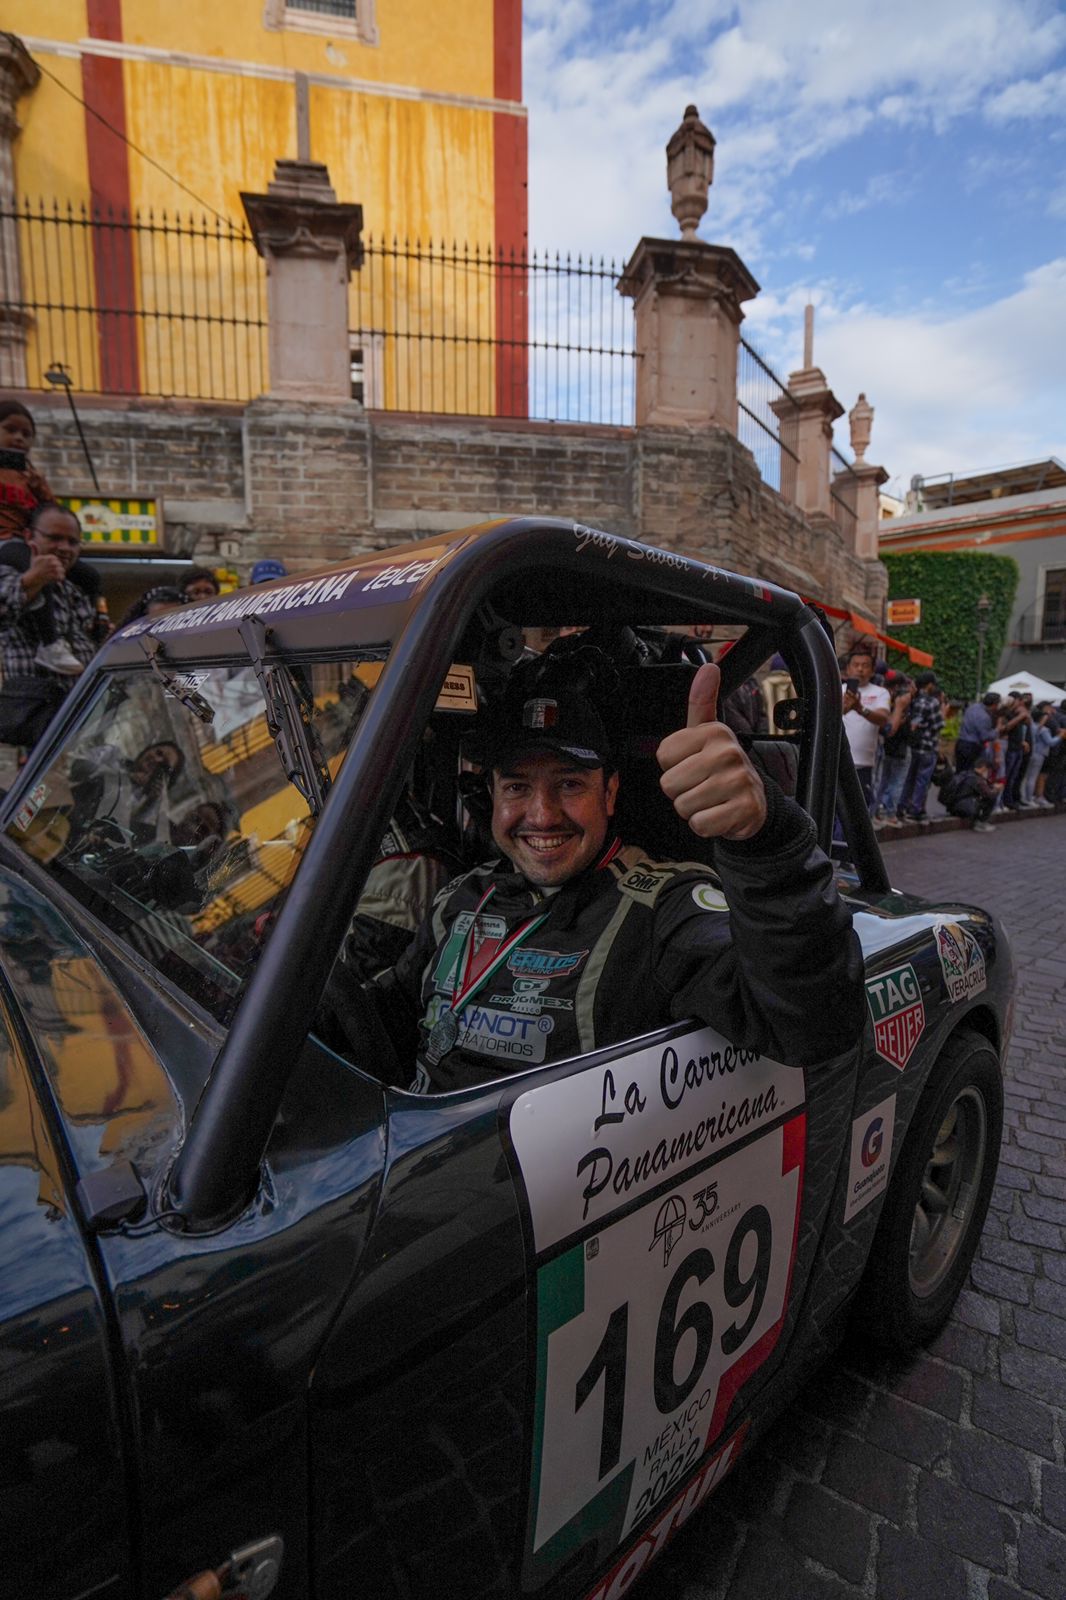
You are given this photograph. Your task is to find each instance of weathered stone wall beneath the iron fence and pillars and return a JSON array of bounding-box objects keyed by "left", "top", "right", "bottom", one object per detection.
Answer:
[{"left": 27, "top": 395, "right": 885, "bottom": 619}]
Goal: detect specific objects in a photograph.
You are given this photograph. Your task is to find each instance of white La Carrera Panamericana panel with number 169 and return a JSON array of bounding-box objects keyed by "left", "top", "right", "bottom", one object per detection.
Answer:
[{"left": 511, "top": 1029, "right": 805, "bottom": 1581}]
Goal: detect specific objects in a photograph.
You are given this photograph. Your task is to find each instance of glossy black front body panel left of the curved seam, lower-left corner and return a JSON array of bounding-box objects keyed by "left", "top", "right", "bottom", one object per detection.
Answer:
[{"left": 0, "top": 972, "right": 130, "bottom": 1600}]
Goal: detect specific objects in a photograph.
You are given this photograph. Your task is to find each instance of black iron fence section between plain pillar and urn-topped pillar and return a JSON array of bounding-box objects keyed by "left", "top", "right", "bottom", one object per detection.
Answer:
[{"left": 351, "top": 238, "right": 635, "bottom": 426}]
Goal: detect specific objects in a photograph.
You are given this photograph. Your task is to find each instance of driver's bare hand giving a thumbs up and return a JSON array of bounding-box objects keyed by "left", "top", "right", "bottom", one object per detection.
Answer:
[{"left": 655, "top": 664, "right": 767, "bottom": 838}]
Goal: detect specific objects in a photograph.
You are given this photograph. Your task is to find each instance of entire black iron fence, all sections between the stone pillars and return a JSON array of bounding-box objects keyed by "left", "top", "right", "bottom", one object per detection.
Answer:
[{"left": 0, "top": 200, "right": 856, "bottom": 512}]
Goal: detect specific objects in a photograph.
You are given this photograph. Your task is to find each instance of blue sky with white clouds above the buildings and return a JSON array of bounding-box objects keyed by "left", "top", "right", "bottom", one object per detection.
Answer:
[{"left": 523, "top": 0, "right": 1066, "bottom": 491}]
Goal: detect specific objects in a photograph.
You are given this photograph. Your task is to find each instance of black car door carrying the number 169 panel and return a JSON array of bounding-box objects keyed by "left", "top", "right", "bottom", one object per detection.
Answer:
[{"left": 311, "top": 1027, "right": 855, "bottom": 1597}]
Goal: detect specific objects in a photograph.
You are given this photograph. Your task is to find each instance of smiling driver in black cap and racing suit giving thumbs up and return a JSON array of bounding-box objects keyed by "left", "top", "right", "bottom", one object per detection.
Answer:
[{"left": 373, "top": 666, "right": 864, "bottom": 1093}]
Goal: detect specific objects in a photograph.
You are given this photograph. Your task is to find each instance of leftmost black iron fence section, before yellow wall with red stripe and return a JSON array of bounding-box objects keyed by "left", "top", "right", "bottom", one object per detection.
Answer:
[{"left": 0, "top": 200, "right": 267, "bottom": 400}]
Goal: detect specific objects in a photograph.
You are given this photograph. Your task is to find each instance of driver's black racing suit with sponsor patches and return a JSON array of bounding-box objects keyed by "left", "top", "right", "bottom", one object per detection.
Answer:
[{"left": 371, "top": 784, "right": 866, "bottom": 1090}]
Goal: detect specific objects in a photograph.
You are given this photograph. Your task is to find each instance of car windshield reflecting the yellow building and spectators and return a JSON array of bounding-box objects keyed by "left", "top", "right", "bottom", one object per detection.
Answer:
[{"left": 6, "top": 658, "right": 381, "bottom": 1022}]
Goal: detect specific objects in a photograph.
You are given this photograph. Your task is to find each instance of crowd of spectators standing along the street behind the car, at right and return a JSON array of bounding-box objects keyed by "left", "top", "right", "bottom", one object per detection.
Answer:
[{"left": 840, "top": 643, "right": 1066, "bottom": 834}]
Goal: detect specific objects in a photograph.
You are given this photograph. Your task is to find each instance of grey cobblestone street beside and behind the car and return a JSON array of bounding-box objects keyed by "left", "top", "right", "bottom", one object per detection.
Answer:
[{"left": 640, "top": 816, "right": 1066, "bottom": 1600}]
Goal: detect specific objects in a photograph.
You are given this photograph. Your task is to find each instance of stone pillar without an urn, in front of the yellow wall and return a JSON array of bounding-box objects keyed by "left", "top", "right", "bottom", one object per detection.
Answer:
[{"left": 240, "top": 160, "right": 363, "bottom": 400}]
